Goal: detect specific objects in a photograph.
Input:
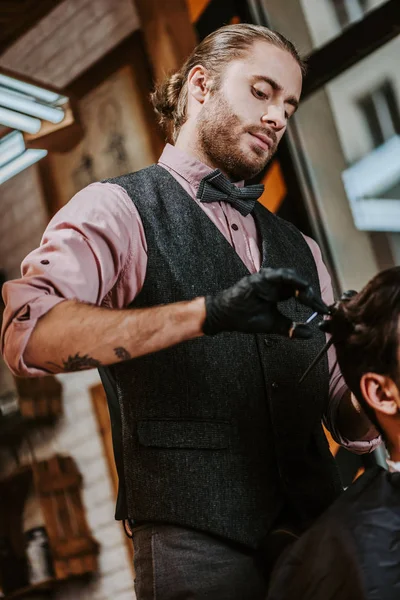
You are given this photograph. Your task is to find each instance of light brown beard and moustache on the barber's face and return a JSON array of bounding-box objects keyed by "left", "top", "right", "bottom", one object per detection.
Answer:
[{"left": 198, "top": 91, "right": 278, "bottom": 181}]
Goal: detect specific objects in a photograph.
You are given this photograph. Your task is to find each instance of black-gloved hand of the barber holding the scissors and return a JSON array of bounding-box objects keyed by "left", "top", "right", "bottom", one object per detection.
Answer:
[{"left": 203, "top": 269, "right": 328, "bottom": 339}]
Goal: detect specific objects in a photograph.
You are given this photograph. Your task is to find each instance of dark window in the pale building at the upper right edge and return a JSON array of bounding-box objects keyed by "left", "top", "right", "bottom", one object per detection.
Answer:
[{"left": 359, "top": 81, "right": 400, "bottom": 148}]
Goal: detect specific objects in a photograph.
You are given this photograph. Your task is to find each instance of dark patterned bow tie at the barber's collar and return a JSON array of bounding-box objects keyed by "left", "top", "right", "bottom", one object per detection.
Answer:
[{"left": 197, "top": 169, "right": 264, "bottom": 216}]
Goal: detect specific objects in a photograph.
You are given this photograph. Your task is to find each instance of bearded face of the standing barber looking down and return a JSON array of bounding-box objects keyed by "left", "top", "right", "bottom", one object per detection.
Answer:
[{"left": 198, "top": 41, "right": 302, "bottom": 181}]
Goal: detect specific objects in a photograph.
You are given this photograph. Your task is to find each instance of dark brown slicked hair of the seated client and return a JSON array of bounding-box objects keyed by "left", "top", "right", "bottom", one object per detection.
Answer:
[{"left": 329, "top": 267, "right": 400, "bottom": 431}]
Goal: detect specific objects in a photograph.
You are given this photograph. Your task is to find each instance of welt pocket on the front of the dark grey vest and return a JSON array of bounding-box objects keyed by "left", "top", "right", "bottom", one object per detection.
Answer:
[{"left": 137, "top": 419, "right": 231, "bottom": 450}]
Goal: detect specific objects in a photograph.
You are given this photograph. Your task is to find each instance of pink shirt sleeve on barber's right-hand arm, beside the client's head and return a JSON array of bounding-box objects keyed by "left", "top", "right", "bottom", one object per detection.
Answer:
[{"left": 304, "top": 236, "right": 382, "bottom": 454}]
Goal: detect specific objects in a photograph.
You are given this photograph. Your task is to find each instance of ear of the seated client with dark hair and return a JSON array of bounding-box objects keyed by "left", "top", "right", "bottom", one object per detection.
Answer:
[{"left": 360, "top": 373, "right": 400, "bottom": 415}]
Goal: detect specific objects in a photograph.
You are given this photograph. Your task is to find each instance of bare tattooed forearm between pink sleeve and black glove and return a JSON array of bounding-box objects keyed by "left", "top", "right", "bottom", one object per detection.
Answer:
[{"left": 25, "top": 297, "right": 206, "bottom": 373}]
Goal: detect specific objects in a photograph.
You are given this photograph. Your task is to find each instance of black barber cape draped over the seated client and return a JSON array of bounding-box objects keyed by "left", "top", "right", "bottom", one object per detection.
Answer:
[{"left": 268, "top": 467, "right": 400, "bottom": 600}]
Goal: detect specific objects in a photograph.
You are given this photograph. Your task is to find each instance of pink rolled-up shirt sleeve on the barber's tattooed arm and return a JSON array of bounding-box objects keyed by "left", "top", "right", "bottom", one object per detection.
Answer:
[{"left": 1, "top": 183, "right": 147, "bottom": 377}]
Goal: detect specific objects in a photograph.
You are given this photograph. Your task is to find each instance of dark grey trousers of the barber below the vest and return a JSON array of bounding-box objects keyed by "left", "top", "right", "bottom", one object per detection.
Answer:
[{"left": 132, "top": 523, "right": 296, "bottom": 600}]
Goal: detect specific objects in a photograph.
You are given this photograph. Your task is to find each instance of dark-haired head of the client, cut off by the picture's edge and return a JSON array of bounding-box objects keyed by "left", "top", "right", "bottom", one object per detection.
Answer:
[{"left": 329, "top": 267, "right": 400, "bottom": 447}]
